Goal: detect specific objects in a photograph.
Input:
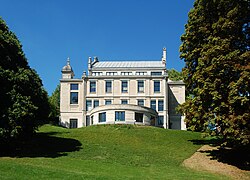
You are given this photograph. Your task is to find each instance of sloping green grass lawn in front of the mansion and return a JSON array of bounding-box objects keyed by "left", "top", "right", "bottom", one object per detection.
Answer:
[{"left": 0, "top": 125, "right": 225, "bottom": 179}]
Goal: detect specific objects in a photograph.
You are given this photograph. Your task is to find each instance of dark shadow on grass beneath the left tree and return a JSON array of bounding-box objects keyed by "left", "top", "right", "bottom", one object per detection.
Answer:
[{"left": 0, "top": 132, "right": 82, "bottom": 158}]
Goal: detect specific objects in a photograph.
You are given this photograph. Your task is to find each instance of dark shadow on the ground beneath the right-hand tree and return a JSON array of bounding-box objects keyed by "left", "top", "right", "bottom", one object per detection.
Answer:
[{"left": 190, "top": 139, "right": 250, "bottom": 171}]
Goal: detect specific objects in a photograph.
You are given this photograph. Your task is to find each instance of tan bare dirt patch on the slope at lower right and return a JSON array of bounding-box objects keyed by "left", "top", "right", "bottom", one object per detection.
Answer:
[{"left": 183, "top": 145, "right": 250, "bottom": 180}]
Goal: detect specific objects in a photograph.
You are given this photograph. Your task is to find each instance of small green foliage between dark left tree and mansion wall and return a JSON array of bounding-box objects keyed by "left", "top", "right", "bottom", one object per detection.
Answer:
[{"left": 49, "top": 85, "right": 60, "bottom": 124}]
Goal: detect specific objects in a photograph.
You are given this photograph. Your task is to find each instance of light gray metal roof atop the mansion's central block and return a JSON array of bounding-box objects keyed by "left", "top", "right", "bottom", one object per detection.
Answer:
[{"left": 92, "top": 61, "right": 165, "bottom": 69}]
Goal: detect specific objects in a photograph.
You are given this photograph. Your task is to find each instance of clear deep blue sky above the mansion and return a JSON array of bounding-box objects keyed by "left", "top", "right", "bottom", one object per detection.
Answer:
[{"left": 0, "top": 0, "right": 194, "bottom": 95}]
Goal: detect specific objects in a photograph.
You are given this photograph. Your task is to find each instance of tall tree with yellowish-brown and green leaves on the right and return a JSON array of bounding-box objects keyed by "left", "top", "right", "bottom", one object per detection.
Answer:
[{"left": 180, "top": 0, "right": 250, "bottom": 145}]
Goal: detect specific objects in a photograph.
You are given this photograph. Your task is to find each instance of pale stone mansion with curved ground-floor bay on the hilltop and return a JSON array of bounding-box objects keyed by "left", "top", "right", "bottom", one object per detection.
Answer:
[{"left": 60, "top": 48, "right": 186, "bottom": 130}]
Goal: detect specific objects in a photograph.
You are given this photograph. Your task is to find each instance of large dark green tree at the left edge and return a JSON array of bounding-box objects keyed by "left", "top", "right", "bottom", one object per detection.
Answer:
[{"left": 0, "top": 17, "right": 49, "bottom": 139}]
